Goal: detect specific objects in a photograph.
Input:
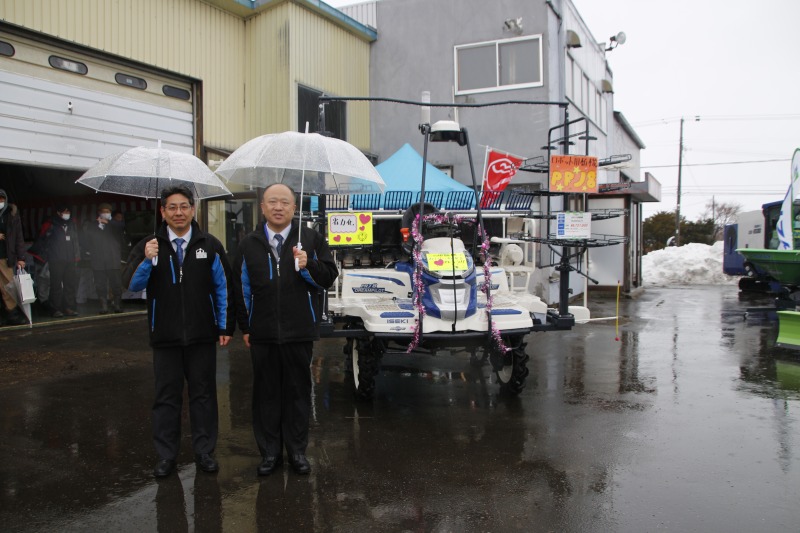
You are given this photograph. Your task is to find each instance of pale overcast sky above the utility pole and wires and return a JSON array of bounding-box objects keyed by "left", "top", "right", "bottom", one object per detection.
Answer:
[{"left": 327, "top": 0, "right": 800, "bottom": 220}]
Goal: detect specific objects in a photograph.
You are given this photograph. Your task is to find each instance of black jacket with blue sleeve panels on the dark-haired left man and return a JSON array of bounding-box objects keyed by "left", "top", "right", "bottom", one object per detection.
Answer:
[{"left": 122, "top": 221, "right": 235, "bottom": 348}]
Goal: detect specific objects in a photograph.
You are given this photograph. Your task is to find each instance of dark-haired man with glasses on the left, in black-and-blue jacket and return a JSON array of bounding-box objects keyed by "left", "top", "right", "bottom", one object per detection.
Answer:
[{"left": 123, "top": 186, "right": 235, "bottom": 477}]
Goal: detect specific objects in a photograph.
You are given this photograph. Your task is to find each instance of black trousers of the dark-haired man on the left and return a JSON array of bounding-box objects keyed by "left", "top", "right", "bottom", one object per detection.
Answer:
[{"left": 153, "top": 343, "right": 219, "bottom": 459}]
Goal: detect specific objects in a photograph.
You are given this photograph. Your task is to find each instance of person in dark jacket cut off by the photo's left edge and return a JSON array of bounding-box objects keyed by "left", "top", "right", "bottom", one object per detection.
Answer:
[{"left": 0, "top": 189, "right": 28, "bottom": 326}]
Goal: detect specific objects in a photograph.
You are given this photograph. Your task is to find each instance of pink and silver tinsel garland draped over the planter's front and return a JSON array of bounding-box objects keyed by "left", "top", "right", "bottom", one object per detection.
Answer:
[{"left": 406, "top": 213, "right": 510, "bottom": 353}]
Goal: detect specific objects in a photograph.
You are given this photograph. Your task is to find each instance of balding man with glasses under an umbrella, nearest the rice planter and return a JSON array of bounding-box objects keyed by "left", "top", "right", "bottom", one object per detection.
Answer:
[{"left": 234, "top": 184, "right": 339, "bottom": 476}]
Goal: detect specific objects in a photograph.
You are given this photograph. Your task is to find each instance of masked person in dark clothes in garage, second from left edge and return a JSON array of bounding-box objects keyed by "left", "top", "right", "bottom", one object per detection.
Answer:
[{"left": 45, "top": 204, "right": 80, "bottom": 318}]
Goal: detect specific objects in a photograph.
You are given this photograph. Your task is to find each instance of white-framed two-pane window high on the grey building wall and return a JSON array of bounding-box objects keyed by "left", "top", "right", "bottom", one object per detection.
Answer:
[{"left": 454, "top": 35, "right": 543, "bottom": 94}]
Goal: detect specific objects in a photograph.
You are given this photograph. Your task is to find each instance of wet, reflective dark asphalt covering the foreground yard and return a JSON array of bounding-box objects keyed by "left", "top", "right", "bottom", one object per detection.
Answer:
[{"left": 0, "top": 286, "right": 800, "bottom": 532}]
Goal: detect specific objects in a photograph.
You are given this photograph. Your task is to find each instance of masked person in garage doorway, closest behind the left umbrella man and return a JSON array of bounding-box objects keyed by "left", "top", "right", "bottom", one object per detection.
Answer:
[{"left": 84, "top": 204, "right": 122, "bottom": 315}]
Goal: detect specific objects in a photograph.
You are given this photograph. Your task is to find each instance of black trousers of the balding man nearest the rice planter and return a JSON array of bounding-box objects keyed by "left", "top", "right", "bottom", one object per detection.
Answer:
[{"left": 250, "top": 341, "right": 314, "bottom": 457}]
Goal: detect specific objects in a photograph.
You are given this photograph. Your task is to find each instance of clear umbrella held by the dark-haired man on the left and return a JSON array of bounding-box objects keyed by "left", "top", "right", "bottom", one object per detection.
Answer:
[{"left": 77, "top": 143, "right": 231, "bottom": 200}]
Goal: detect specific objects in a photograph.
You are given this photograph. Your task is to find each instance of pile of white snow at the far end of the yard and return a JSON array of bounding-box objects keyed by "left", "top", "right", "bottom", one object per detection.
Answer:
[{"left": 642, "top": 241, "right": 739, "bottom": 286}]
